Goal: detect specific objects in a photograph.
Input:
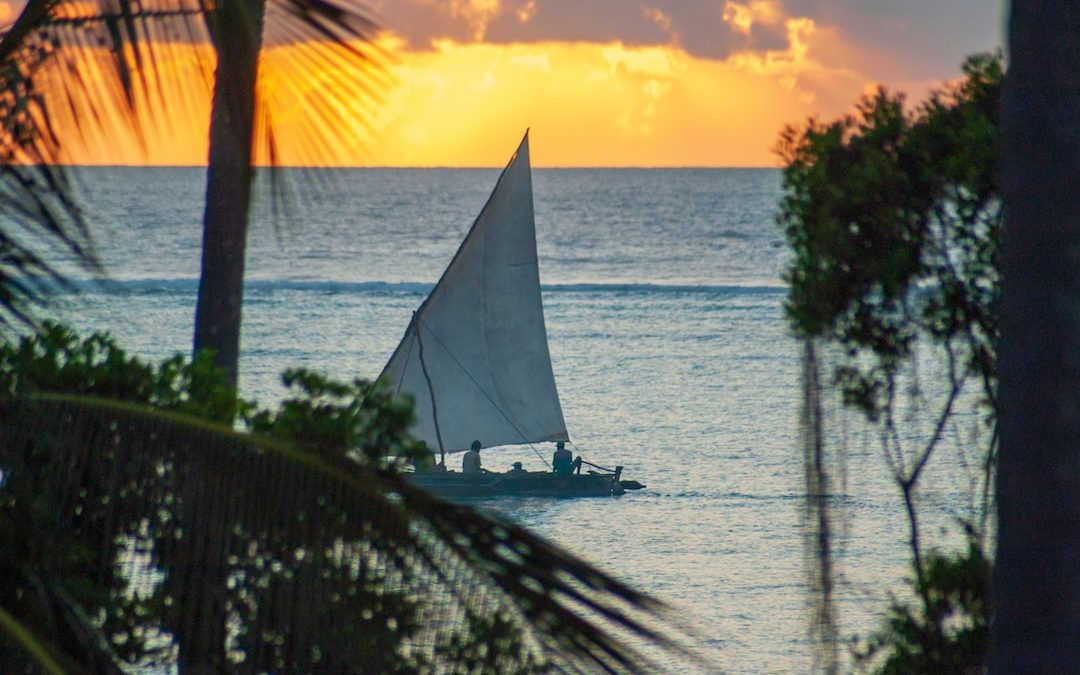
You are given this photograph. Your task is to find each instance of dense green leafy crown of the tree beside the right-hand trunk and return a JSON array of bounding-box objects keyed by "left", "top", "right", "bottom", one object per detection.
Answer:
[{"left": 778, "top": 55, "right": 1002, "bottom": 419}]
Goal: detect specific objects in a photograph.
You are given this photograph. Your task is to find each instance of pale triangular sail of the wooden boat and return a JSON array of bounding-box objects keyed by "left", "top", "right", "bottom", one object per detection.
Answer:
[{"left": 380, "top": 133, "right": 568, "bottom": 453}]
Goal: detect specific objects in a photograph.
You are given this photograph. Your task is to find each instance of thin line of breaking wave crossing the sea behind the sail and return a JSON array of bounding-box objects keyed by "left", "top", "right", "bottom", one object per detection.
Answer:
[{"left": 52, "top": 278, "right": 787, "bottom": 296}]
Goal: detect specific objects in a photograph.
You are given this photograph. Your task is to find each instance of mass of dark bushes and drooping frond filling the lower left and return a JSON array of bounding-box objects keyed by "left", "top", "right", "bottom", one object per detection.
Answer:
[{"left": 0, "top": 325, "right": 669, "bottom": 673}]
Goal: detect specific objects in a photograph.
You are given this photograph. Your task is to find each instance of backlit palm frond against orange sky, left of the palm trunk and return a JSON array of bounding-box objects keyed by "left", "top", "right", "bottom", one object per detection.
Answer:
[{"left": 0, "top": 0, "right": 213, "bottom": 161}]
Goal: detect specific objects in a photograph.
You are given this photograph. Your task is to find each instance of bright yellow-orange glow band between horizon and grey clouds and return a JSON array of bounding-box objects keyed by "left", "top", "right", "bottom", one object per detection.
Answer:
[{"left": 42, "top": 24, "right": 881, "bottom": 166}]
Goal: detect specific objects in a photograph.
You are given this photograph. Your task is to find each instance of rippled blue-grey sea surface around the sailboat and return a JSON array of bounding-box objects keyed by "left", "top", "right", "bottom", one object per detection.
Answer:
[{"left": 46, "top": 167, "right": 984, "bottom": 673}]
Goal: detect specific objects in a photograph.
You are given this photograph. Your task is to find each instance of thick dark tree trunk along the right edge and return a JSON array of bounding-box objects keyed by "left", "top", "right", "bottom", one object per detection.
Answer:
[{"left": 990, "top": 0, "right": 1080, "bottom": 673}]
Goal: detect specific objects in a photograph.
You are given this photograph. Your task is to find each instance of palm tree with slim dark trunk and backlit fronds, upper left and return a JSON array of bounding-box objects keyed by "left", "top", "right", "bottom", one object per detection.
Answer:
[{"left": 0, "top": 0, "right": 384, "bottom": 381}]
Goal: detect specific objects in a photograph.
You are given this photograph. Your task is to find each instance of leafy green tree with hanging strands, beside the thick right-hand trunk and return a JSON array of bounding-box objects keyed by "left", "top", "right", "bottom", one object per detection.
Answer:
[{"left": 778, "top": 54, "right": 1003, "bottom": 670}]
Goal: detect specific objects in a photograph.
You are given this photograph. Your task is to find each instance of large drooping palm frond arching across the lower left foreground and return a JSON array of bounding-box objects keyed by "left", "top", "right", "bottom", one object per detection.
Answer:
[{"left": 0, "top": 397, "right": 673, "bottom": 673}]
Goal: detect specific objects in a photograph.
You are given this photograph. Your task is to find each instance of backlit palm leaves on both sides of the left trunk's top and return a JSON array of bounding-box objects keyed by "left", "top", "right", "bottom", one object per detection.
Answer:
[{"left": 0, "top": 0, "right": 389, "bottom": 165}]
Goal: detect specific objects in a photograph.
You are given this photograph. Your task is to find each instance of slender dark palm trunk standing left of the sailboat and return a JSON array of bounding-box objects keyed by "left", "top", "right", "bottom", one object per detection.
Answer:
[{"left": 194, "top": 0, "right": 266, "bottom": 383}]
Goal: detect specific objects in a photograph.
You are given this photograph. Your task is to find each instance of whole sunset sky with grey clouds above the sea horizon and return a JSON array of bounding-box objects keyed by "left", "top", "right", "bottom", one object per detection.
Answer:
[{"left": 10, "top": 0, "right": 1004, "bottom": 166}]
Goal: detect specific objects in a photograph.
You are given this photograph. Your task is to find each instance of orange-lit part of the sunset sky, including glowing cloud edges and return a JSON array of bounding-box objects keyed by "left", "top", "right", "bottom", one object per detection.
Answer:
[{"left": 23, "top": 0, "right": 997, "bottom": 166}]
